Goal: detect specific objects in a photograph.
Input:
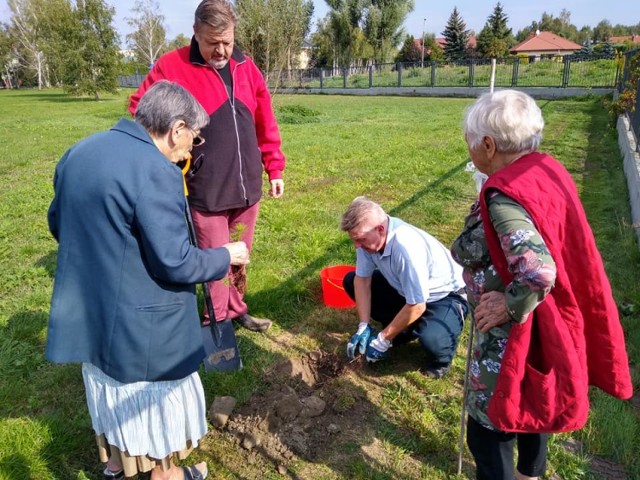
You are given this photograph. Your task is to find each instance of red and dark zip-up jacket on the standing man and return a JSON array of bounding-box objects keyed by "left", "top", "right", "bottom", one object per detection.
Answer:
[{"left": 129, "top": 38, "right": 285, "bottom": 212}]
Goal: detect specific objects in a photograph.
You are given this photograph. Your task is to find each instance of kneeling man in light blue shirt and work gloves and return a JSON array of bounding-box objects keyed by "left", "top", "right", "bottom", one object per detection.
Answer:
[{"left": 341, "top": 197, "right": 469, "bottom": 378}]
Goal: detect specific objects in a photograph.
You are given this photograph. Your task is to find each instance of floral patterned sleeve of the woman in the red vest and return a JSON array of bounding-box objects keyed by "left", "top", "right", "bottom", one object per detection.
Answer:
[{"left": 488, "top": 192, "right": 556, "bottom": 323}]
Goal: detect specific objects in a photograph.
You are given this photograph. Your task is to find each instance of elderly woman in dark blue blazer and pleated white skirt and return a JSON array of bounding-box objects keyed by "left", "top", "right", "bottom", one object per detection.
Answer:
[{"left": 46, "top": 81, "right": 248, "bottom": 480}]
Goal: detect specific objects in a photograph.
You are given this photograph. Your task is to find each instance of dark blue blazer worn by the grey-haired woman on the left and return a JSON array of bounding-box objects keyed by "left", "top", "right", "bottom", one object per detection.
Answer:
[{"left": 46, "top": 119, "right": 229, "bottom": 383}]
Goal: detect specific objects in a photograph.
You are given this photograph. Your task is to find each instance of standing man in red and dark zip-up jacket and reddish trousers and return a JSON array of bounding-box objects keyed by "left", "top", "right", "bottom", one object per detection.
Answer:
[{"left": 129, "top": 0, "right": 285, "bottom": 331}]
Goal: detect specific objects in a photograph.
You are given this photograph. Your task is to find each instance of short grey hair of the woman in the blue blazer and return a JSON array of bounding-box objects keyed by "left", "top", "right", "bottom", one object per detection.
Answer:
[{"left": 135, "top": 80, "right": 209, "bottom": 135}]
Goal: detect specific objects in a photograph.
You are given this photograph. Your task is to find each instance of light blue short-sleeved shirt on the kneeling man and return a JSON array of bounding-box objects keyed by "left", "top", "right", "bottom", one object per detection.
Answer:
[{"left": 356, "top": 217, "right": 464, "bottom": 305}]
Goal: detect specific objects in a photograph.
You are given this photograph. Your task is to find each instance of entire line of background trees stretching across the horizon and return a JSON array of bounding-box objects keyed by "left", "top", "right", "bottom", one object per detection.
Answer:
[{"left": 0, "top": 0, "right": 640, "bottom": 94}]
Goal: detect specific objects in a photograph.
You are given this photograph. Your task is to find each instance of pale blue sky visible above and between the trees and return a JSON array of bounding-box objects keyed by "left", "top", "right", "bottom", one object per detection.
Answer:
[{"left": 0, "top": 0, "right": 640, "bottom": 46}]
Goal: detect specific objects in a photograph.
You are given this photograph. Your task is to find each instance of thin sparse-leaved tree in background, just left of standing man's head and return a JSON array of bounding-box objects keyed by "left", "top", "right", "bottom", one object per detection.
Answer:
[{"left": 126, "top": 0, "right": 166, "bottom": 65}]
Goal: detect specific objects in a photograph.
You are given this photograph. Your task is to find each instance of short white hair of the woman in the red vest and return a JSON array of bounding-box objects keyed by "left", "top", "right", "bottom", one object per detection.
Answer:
[{"left": 463, "top": 90, "right": 544, "bottom": 154}]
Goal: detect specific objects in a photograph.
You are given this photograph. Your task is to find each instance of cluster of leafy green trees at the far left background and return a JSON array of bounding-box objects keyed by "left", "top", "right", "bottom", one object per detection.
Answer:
[{"left": 0, "top": 0, "right": 118, "bottom": 97}]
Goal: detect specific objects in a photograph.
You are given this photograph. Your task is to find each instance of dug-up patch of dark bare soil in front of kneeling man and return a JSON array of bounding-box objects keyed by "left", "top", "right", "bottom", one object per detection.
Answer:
[{"left": 210, "top": 351, "right": 373, "bottom": 474}]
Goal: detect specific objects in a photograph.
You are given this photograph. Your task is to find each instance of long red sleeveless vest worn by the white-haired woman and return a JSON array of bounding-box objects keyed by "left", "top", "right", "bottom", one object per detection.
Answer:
[{"left": 480, "top": 153, "right": 633, "bottom": 433}]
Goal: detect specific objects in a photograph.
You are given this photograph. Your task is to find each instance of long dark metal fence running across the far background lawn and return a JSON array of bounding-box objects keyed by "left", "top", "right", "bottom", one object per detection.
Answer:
[{"left": 267, "top": 55, "right": 621, "bottom": 89}]
